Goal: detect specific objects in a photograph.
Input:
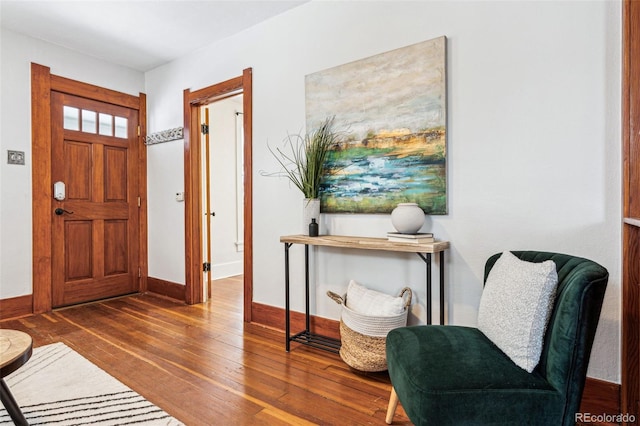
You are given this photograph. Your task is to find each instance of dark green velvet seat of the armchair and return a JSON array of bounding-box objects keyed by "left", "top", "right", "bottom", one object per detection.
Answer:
[{"left": 386, "top": 325, "right": 563, "bottom": 426}]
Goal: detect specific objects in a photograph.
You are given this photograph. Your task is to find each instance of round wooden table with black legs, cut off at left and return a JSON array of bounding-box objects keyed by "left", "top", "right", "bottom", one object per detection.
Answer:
[{"left": 0, "top": 329, "right": 33, "bottom": 426}]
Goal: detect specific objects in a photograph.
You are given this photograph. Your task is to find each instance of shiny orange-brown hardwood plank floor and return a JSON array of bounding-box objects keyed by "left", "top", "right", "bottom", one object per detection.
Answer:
[{"left": 0, "top": 277, "right": 411, "bottom": 425}]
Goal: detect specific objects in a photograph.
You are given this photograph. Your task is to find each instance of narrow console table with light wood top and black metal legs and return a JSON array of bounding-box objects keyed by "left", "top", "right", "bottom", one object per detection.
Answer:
[{"left": 280, "top": 235, "right": 449, "bottom": 353}]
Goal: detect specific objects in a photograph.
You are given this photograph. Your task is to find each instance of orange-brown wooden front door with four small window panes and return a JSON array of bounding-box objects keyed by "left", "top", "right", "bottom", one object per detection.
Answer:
[{"left": 51, "top": 92, "right": 139, "bottom": 307}]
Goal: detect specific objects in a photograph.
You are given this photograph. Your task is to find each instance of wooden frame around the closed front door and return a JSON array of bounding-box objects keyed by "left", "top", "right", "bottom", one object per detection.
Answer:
[{"left": 31, "top": 63, "right": 148, "bottom": 314}]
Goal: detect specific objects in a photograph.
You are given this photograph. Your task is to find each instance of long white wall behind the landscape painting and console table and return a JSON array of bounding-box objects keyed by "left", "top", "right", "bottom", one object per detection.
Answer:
[{"left": 146, "top": 1, "right": 621, "bottom": 382}]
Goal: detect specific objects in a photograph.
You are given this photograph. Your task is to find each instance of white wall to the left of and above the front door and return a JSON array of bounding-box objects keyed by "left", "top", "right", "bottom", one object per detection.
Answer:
[{"left": 0, "top": 28, "right": 144, "bottom": 299}]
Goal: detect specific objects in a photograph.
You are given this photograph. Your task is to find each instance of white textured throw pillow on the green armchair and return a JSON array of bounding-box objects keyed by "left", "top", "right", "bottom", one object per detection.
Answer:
[{"left": 478, "top": 251, "right": 558, "bottom": 373}]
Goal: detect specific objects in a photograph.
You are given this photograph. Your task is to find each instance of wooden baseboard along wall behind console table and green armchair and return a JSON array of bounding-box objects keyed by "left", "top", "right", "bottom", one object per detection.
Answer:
[{"left": 251, "top": 302, "right": 620, "bottom": 415}]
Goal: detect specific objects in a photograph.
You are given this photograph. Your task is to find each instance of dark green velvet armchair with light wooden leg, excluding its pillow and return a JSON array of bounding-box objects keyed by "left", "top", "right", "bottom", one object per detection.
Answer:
[{"left": 386, "top": 251, "right": 608, "bottom": 426}]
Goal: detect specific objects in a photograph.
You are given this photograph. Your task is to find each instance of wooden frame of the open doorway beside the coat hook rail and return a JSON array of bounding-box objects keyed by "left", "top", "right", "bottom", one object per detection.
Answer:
[{"left": 184, "top": 68, "right": 253, "bottom": 322}]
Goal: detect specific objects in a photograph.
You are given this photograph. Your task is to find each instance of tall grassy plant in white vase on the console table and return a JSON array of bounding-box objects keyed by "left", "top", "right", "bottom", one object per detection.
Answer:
[{"left": 269, "top": 117, "right": 340, "bottom": 233}]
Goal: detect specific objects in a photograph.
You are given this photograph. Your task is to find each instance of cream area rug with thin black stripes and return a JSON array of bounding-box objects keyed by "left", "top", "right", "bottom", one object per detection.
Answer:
[{"left": 0, "top": 343, "right": 182, "bottom": 426}]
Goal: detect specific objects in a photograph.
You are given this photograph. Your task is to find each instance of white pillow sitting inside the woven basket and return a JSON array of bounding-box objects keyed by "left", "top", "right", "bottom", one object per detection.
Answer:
[{"left": 347, "top": 280, "right": 405, "bottom": 317}]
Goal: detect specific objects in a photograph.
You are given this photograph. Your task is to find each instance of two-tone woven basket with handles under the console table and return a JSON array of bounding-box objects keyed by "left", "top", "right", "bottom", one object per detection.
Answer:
[{"left": 327, "top": 287, "right": 412, "bottom": 372}]
